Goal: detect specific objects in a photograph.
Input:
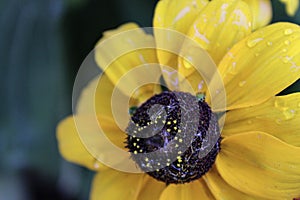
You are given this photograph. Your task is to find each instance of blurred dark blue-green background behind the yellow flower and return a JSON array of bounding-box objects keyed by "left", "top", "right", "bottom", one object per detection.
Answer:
[{"left": 0, "top": 0, "right": 300, "bottom": 200}]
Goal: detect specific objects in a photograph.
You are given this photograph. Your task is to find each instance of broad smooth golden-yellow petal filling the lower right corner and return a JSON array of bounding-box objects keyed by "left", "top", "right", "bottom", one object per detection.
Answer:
[{"left": 216, "top": 132, "right": 300, "bottom": 199}]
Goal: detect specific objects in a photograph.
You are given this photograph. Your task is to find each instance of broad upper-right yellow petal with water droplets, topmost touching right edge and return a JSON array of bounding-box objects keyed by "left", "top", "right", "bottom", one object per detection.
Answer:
[{"left": 211, "top": 23, "right": 300, "bottom": 109}]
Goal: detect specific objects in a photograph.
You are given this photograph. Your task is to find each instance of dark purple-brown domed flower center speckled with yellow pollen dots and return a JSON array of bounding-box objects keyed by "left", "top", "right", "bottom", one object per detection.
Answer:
[{"left": 126, "top": 91, "right": 221, "bottom": 184}]
